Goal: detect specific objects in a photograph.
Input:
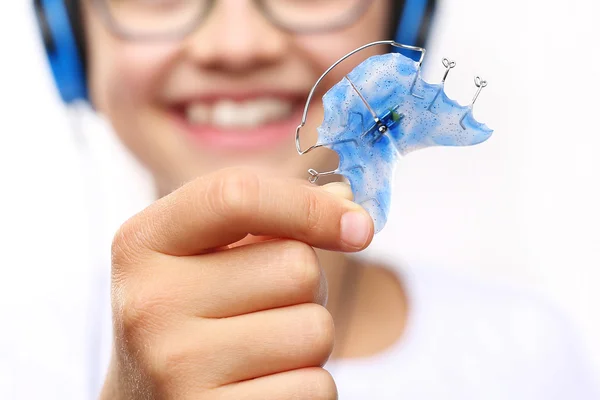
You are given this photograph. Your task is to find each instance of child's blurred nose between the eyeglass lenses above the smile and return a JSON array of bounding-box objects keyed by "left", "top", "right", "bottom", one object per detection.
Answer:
[{"left": 186, "top": 0, "right": 289, "bottom": 71}]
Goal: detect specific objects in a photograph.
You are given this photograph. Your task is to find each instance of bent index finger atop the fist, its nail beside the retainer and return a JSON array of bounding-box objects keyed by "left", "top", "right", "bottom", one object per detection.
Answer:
[{"left": 118, "top": 168, "right": 373, "bottom": 256}]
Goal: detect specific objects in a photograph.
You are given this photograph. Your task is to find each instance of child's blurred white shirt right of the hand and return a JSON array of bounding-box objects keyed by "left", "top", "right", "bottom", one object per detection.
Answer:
[{"left": 326, "top": 268, "right": 600, "bottom": 400}]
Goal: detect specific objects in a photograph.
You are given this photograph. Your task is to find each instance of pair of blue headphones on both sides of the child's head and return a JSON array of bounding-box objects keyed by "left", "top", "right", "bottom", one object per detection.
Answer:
[{"left": 33, "top": 0, "right": 436, "bottom": 104}]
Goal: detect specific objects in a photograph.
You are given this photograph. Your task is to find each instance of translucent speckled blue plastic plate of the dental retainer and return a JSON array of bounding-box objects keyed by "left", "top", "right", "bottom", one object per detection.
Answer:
[{"left": 317, "top": 53, "right": 492, "bottom": 232}]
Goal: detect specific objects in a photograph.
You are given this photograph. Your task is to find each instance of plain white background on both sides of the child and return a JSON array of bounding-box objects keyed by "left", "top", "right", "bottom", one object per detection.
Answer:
[{"left": 0, "top": 0, "right": 600, "bottom": 388}]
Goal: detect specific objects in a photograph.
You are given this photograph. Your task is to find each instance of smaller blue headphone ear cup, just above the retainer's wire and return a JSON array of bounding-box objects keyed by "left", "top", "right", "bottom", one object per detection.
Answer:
[{"left": 395, "top": 0, "right": 437, "bottom": 61}]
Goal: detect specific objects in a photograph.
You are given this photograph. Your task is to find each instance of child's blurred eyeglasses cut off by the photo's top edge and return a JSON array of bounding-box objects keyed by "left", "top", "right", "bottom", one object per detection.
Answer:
[{"left": 92, "top": 0, "right": 373, "bottom": 40}]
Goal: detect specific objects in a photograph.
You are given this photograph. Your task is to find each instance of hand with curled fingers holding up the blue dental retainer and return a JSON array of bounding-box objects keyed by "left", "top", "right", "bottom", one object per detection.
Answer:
[{"left": 102, "top": 168, "right": 373, "bottom": 400}]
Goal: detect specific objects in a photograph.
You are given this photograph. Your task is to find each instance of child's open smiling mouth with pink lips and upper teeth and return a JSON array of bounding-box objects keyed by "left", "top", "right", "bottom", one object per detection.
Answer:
[{"left": 175, "top": 95, "right": 305, "bottom": 151}]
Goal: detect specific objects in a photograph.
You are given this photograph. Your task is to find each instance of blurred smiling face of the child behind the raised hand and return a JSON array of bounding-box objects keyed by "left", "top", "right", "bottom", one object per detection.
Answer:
[{"left": 84, "top": 0, "right": 391, "bottom": 193}]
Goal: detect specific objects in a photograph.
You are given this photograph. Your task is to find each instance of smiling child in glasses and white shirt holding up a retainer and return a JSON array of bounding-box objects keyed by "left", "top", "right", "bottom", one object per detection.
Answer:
[{"left": 15, "top": 0, "right": 591, "bottom": 399}]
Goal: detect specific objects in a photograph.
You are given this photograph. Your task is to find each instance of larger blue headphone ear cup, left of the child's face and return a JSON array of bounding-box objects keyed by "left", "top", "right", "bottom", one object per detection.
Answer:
[{"left": 34, "top": 0, "right": 88, "bottom": 104}]
